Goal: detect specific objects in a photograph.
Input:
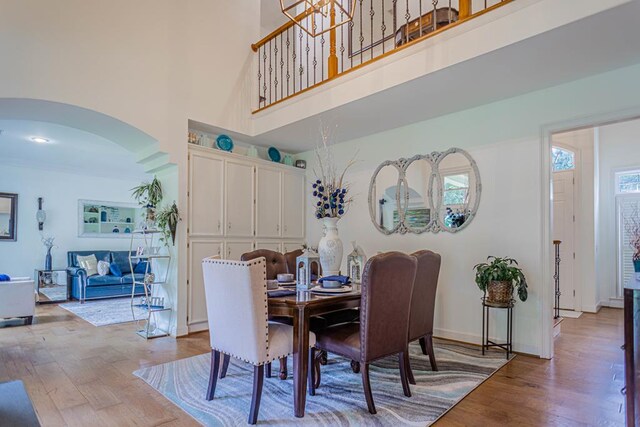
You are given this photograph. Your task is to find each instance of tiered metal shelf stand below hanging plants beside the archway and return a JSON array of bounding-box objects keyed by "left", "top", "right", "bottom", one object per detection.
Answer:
[{"left": 129, "top": 229, "right": 173, "bottom": 339}]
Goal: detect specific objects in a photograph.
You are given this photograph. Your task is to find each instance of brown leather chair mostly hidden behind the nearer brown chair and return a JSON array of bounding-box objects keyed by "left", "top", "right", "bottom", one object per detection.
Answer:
[{"left": 406, "top": 250, "right": 441, "bottom": 384}]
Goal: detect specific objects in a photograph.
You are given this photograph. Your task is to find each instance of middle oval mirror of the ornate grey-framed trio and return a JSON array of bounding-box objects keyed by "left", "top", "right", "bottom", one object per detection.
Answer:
[{"left": 400, "top": 156, "right": 436, "bottom": 234}]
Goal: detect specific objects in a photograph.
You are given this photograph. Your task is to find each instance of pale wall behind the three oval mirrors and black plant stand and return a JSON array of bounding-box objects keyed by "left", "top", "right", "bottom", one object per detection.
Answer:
[{"left": 304, "top": 62, "right": 640, "bottom": 354}]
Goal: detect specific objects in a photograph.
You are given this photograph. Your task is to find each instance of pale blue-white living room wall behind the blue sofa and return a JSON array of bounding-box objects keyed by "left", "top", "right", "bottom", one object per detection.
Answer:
[{"left": 0, "top": 164, "right": 148, "bottom": 276}]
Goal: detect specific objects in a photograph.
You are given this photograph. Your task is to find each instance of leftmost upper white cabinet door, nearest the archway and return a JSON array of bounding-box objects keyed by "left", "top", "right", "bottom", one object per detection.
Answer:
[{"left": 189, "top": 153, "right": 224, "bottom": 237}]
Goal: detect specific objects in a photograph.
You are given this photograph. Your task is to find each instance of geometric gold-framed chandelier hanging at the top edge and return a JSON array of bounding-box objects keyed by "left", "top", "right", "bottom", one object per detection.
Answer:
[{"left": 280, "top": 0, "right": 356, "bottom": 37}]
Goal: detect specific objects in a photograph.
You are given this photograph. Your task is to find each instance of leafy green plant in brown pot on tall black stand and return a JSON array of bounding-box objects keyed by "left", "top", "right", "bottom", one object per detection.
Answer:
[{"left": 473, "top": 256, "right": 529, "bottom": 305}]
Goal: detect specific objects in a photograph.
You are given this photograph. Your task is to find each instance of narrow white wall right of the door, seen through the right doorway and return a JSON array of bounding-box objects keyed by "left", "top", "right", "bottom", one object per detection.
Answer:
[{"left": 552, "top": 128, "right": 600, "bottom": 313}]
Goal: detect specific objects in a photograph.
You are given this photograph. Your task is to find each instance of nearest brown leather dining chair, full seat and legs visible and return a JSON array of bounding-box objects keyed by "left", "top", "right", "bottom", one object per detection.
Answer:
[{"left": 309, "top": 252, "right": 418, "bottom": 414}]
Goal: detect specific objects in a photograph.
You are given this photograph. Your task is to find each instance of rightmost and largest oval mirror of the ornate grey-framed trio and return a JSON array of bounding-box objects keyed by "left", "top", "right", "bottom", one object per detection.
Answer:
[{"left": 436, "top": 148, "right": 482, "bottom": 233}]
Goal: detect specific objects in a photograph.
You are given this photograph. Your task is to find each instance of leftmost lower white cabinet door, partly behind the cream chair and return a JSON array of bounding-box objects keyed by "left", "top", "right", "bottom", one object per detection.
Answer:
[{"left": 187, "top": 240, "right": 222, "bottom": 325}]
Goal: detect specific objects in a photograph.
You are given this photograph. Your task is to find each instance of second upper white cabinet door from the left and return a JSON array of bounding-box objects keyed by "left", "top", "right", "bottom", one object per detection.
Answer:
[{"left": 225, "top": 161, "right": 255, "bottom": 237}]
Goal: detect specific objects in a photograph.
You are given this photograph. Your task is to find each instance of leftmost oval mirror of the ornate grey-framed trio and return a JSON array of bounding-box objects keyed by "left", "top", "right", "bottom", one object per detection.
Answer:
[{"left": 369, "top": 161, "right": 403, "bottom": 234}]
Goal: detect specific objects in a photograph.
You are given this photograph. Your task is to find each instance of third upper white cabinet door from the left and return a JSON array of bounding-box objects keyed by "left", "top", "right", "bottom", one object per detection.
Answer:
[{"left": 256, "top": 166, "right": 282, "bottom": 237}]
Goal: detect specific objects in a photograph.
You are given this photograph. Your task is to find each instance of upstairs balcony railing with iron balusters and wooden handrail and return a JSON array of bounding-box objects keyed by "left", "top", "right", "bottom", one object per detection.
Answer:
[{"left": 251, "top": 0, "right": 514, "bottom": 112}]
